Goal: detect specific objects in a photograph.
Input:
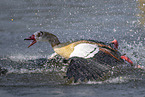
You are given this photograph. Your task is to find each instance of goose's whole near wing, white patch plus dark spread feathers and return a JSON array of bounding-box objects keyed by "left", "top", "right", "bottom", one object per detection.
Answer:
[{"left": 66, "top": 42, "right": 124, "bottom": 82}]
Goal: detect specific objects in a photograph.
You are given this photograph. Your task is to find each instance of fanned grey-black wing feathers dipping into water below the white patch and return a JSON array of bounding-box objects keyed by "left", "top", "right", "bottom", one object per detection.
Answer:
[{"left": 66, "top": 57, "right": 109, "bottom": 82}]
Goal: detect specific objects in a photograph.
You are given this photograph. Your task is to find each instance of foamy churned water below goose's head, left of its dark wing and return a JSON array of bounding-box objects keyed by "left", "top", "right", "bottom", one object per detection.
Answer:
[{"left": 0, "top": 54, "right": 68, "bottom": 74}]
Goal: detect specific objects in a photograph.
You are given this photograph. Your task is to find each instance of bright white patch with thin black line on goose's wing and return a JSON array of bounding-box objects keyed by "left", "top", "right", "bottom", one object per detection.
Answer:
[{"left": 70, "top": 43, "right": 99, "bottom": 58}]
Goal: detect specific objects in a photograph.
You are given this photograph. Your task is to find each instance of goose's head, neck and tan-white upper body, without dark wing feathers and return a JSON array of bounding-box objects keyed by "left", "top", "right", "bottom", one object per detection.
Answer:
[{"left": 24, "top": 31, "right": 119, "bottom": 60}]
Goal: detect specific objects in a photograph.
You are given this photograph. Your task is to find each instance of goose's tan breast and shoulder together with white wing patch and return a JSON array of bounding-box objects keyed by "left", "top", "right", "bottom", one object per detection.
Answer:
[{"left": 53, "top": 40, "right": 99, "bottom": 59}]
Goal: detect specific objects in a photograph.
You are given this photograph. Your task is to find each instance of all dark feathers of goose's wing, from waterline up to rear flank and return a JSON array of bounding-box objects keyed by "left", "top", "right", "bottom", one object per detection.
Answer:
[{"left": 66, "top": 51, "right": 123, "bottom": 82}]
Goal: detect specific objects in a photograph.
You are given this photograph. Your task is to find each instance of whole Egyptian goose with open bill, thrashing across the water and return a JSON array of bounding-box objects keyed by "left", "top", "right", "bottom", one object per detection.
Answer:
[{"left": 24, "top": 31, "right": 133, "bottom": 81}]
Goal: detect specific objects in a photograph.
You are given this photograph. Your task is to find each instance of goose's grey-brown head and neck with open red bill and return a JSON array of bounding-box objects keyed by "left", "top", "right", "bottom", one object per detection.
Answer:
[{"left": 24, "top": 31, "right": 60, "bottom": 48}]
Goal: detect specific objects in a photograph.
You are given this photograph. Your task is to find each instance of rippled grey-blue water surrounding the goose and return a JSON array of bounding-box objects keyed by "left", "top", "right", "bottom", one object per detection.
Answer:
[{"left": 0, "top": 0, "right": 145, "bottom": 97}]
